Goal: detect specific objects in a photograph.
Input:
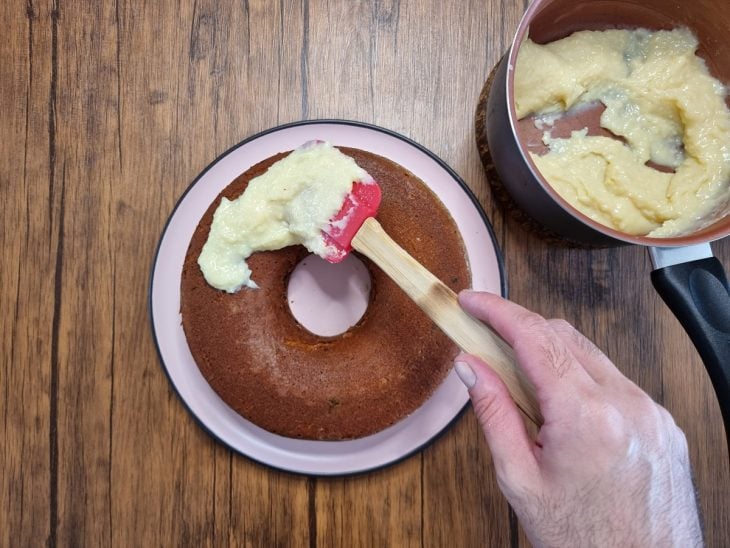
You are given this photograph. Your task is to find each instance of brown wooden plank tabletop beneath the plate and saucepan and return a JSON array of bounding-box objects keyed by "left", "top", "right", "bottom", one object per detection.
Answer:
[{"left": 0, "top": 0, "right": 730, "bottom": 547}]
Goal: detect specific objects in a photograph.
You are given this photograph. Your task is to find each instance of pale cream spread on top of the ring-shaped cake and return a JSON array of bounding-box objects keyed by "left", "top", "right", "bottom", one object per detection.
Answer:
[{"left": 198, "top": 141, "right": 372, "bottom": 293}]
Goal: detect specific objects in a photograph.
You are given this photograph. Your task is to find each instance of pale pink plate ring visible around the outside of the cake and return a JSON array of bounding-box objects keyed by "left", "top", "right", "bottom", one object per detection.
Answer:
[{"left": 149, "top": 120, "right": 506, "bottom": 476}]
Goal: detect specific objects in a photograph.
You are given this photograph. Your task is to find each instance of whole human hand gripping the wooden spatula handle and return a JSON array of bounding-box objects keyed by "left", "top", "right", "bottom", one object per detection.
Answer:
[{"left": 455, "top": 291, "right": 703, "bottom": 547}]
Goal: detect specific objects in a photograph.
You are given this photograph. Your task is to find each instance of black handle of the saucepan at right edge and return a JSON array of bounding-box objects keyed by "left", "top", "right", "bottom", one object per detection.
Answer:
[{"left": 651, "top": 257, "right": 730, "bottom": 448}]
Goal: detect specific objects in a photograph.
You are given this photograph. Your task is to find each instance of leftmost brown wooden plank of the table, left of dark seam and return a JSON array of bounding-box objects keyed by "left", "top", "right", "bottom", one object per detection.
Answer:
[{"left": 0, "top": 3, "right": 56, "bottom": 546}]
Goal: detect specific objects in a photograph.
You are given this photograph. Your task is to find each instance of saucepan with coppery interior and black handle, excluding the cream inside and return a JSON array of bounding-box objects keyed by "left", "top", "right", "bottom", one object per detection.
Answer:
[{"left": 486, "top": 0, "right": 730, "bottom": 443}]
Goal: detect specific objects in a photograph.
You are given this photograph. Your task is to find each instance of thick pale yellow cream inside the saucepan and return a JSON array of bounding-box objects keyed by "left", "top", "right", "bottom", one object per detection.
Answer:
[{"left": 515, "top": 28, "right": 730, "bottom": 237}]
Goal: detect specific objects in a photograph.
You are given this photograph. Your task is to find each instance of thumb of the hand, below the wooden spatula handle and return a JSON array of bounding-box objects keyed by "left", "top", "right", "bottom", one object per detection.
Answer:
[{"left": 454, "top": 354, "right": 536, "bottom": 480}]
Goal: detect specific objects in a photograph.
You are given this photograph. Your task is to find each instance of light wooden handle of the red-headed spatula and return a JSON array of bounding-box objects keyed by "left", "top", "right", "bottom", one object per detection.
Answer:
[{"left": 352, "top": 217, "right": 543, "bottom": 426}]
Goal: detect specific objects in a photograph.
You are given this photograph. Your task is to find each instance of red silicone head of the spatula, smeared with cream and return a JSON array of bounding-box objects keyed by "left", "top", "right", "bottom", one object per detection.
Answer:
[{"left": 322, "top": 179, "right": 380, "bottom": 263}]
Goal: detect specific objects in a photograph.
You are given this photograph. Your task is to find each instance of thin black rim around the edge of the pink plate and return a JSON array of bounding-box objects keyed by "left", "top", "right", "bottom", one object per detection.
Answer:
[{"left": 147, "top": 119, "right": 508, "bottom": 478}]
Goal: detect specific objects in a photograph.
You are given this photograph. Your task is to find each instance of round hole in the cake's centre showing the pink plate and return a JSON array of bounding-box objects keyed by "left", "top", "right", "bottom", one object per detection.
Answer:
[{"left": 287, "top": 253, "right": 372, "bottom": 337}]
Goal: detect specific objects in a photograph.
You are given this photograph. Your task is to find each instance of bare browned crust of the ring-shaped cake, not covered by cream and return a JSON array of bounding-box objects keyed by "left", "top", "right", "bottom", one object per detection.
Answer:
[{"left": 181, "top": 148, "right": 470, "bottom": 440}]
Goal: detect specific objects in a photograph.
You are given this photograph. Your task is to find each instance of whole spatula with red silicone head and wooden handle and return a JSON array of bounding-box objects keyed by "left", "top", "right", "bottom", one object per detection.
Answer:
[{"left": 322, "top": 181, "right": 543, "bottom": 426}]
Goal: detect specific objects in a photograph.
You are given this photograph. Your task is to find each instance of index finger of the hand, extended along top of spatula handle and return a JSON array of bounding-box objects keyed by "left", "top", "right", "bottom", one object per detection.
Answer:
[{"left": 459, "top": 291, "right": 595, "bottom": 402}]
